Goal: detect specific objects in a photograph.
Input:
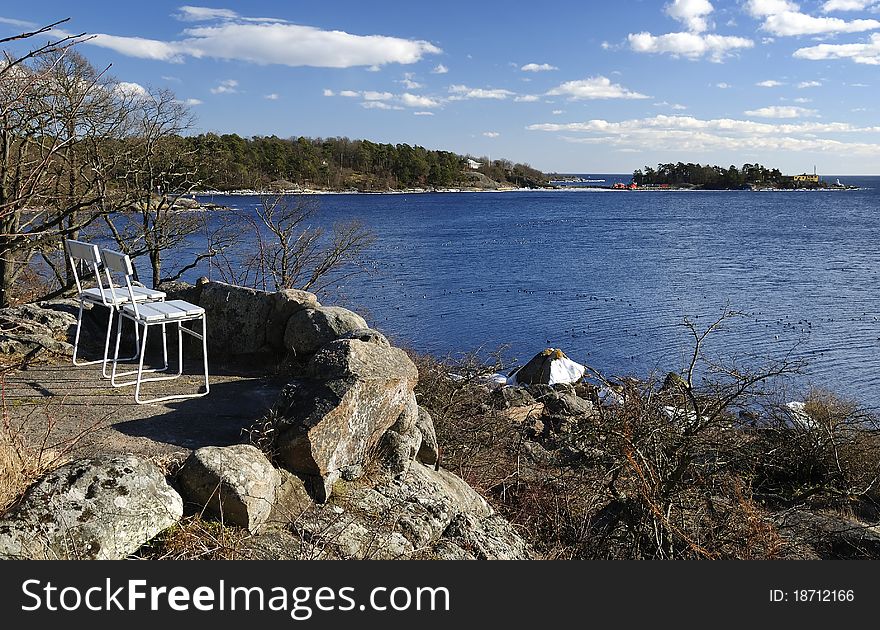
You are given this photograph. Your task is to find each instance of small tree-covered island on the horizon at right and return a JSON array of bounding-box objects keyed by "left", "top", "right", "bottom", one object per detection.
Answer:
[{"left": 633, "top": 162, "right": 843, "bottom": 190}]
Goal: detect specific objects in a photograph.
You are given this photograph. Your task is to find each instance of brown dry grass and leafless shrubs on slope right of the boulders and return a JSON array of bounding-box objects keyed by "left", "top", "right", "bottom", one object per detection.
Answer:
[{"left": 413, "top": 355, "right": 880, "bottom": 559}]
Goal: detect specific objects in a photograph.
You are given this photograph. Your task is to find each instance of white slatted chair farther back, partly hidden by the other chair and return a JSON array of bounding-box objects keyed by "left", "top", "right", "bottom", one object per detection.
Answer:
[{"left": 64, "top": 239, "right": 165, "bottom": 378}]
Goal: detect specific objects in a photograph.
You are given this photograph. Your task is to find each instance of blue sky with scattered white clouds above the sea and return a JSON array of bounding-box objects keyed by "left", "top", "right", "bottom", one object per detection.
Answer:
[{"left": 0, "top": 0, "right": 880, "bottom": 174}]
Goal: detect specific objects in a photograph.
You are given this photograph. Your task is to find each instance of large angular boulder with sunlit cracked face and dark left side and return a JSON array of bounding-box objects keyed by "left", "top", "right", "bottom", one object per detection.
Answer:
[{"left": 274, "top": 339, "right": 418, "bottom": 502}]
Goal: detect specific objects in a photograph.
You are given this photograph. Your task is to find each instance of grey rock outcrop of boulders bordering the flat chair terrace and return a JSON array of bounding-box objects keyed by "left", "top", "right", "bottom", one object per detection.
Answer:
[{"left": 0, "top": 280, "right": 532, "bottom": 559}]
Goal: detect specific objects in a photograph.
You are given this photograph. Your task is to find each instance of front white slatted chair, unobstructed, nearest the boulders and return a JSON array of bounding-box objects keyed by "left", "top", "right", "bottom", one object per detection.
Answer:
[{"left": 101, "top": 250, "right": 210, "bottom": 404}]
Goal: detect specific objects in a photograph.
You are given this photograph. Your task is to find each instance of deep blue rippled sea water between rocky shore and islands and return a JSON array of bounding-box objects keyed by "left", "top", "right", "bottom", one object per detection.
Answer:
[{"left": 190, "top": 175, "right": 880, "bottom": 408}]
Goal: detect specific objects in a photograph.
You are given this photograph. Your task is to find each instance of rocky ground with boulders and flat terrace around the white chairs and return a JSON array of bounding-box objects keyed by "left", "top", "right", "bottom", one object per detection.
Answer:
[{"left": 0, "top": 283, "right": 532, "bottom": 559}]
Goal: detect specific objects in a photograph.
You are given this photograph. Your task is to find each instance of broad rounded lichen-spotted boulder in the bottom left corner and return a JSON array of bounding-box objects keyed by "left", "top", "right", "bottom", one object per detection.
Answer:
[{"left": 0, "top": 455, "right": 183, "bottom": 559}]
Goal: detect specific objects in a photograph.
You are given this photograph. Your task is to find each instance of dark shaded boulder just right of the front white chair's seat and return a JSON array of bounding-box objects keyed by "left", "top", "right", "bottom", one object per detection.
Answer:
[{"left": 199, "top": 282, "right": 274, "bottom": 356}]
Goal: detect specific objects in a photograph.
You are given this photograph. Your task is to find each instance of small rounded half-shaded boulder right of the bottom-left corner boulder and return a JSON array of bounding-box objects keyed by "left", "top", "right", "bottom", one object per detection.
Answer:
[{"left": 177, "top": 444, "right": 281, "bottom": 532}]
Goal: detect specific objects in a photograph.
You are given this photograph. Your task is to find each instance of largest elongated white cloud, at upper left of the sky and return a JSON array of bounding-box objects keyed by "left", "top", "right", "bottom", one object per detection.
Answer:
[{"left": 72, "top": 13, "right": 442, "bottom": 69}]
